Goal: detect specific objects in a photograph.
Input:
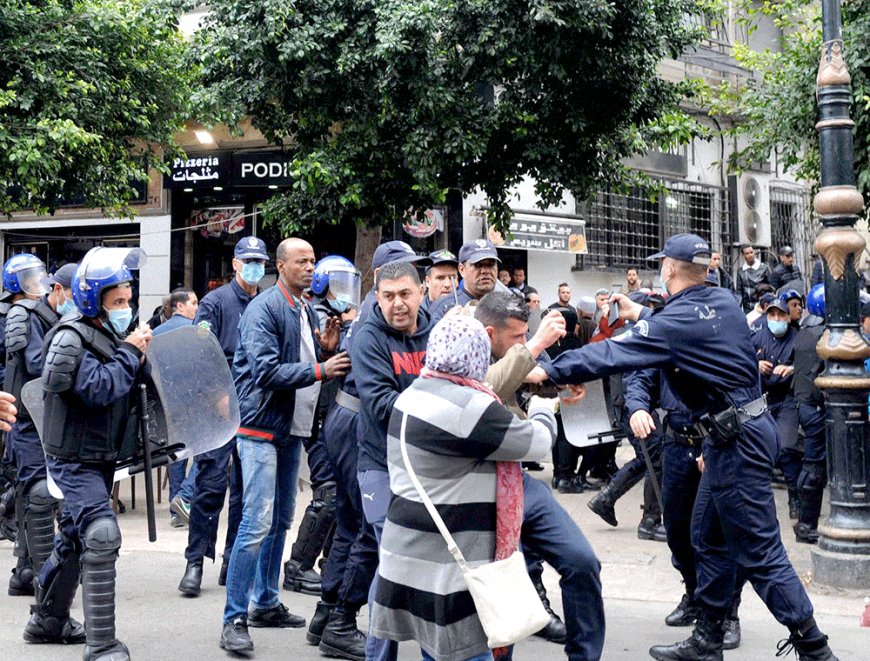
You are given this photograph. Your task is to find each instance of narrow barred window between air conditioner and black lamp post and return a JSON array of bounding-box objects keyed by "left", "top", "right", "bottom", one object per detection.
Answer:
[{"left": 770, "top": 181, "right": 821, "bottom": 279}]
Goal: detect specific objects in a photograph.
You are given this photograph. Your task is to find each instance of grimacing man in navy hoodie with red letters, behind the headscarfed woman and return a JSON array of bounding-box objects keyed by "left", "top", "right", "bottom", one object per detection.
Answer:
[{"left": 352, "top": 262, "right": 431, "bottom": 660}]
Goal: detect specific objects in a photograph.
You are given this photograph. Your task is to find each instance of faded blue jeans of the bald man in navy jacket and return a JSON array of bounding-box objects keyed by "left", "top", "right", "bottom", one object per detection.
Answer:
[{"left": 224, "top": 436, "right": 302, "bottom": 623}]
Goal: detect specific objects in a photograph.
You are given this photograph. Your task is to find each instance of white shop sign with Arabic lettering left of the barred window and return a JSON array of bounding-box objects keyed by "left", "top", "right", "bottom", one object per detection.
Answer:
[{"left": 489, "top": 213, "right": 589, "bottom": 255}]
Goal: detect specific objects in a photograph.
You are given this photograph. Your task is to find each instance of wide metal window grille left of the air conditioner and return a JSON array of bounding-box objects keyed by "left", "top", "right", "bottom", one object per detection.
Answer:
[{"left": 577, "top": 181, "right": 731, "bottom": 269}]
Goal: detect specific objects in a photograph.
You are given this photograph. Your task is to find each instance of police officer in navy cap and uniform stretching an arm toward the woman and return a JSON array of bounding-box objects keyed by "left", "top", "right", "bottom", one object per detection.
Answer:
[{"left": 536, "top": 234, "right": 836, "bottom": 661}]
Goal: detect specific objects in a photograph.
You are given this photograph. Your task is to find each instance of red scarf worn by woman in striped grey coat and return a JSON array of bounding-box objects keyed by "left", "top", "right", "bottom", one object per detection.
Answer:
[{"left": 420, "top": 367, "right": 523, "bottom": 560}]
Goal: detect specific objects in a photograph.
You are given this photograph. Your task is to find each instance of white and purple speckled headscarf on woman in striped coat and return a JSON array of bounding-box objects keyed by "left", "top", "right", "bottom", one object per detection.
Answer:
[{"left": 426, "top": 314, "right": 491, "bottom": 381}]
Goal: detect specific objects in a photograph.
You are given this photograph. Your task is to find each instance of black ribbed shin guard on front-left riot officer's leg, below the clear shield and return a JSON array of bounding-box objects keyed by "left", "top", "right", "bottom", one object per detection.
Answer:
[{"left": 82, "top": 517, "right": 130, "bottom": 661}]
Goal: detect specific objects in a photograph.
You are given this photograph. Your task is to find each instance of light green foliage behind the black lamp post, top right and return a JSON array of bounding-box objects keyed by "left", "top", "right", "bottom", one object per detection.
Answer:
[{"left": 714, "top": 0, "right": 870, "bottom": 200}]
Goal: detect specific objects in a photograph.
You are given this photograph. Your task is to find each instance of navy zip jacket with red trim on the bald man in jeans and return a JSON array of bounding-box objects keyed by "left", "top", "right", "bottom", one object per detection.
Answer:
[{"left": 231, "top": 280, "right": 325, "bottom": 441}]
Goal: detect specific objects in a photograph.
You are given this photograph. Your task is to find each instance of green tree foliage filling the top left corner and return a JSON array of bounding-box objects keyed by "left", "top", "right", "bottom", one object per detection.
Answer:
[{"left": 0, "top": 0, "right": 196, "bottom": 214}]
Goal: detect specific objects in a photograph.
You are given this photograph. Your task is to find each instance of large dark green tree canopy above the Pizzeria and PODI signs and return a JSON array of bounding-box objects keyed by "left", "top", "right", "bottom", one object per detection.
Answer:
[{"left": 196, "top": 0, "right": 699, "bottom": 231}]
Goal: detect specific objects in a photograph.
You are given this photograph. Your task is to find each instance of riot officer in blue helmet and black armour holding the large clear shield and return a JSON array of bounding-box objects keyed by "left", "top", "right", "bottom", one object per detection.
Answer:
[{"left": 25, "top": 248, "right": 151, "bottom": 661}]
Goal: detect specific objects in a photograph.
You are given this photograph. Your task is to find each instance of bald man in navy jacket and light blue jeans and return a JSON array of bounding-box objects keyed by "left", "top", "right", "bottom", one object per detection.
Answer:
[{"left": 220, "top": 238, "right": 350, "bottom": 653}]
